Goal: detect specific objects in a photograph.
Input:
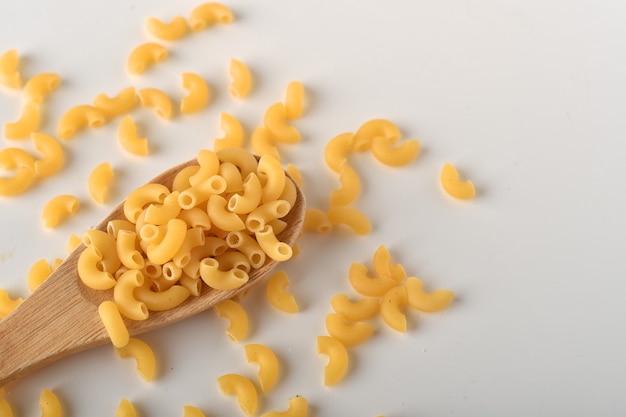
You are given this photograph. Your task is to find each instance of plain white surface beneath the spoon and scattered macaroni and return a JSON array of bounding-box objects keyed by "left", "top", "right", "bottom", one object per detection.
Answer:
[{"left": 0, "top": 0, "right": 626, "bottom": 417}]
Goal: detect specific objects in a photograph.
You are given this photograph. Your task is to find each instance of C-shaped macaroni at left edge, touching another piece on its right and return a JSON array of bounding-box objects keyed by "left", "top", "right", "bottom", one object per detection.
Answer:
[{"left": 0, "top": 148, "right": 35, "bottom": 197}]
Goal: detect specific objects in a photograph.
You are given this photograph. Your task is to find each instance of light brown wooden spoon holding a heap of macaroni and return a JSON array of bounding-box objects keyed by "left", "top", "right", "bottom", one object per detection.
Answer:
[{"left": 0, "top": 159, "right": 306, "bottom": 387}]
